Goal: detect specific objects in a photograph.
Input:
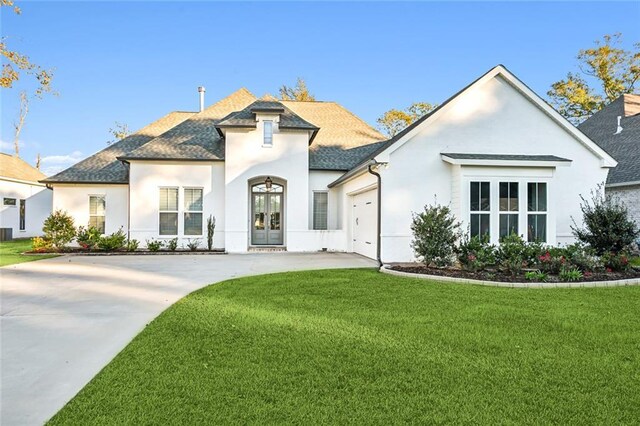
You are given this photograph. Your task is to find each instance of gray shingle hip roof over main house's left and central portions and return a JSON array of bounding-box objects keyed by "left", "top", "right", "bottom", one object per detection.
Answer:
[{"left": 44, "top": 89, "right": 385, "bottom": 184}]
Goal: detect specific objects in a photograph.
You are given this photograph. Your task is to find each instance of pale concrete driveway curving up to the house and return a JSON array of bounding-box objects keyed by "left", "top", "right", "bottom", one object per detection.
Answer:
[{"left": 0, "top": 253, "right": 376, "bottom": 426}]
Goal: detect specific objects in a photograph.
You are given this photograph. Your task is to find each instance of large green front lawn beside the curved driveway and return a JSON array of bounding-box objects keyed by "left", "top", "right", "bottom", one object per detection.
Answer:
[{"left": 51, "top": 270, "right": 640, "bottom": 425}]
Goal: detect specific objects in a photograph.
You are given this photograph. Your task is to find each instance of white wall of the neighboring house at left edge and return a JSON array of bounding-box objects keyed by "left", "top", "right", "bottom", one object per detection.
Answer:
[{"left": 0, "top": 178, "right": 53, "bottom": 238}]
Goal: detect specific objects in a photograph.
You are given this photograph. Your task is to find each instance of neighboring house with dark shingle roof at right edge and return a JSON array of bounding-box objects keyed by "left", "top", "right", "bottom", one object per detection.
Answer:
[{"left": 578, "top": 94, "right": 640, "bottom": 226}]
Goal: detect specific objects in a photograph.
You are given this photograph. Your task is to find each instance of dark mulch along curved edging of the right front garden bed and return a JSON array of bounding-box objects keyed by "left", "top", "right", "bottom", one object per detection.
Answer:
[{"left": 389, "top": 263, "right": 640, "bottom": 283}]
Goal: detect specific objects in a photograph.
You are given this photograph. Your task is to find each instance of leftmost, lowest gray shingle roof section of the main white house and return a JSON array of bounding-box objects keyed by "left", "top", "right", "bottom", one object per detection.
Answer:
[{"left": 41, "top": 111, "right": 194, "bottom": 183}]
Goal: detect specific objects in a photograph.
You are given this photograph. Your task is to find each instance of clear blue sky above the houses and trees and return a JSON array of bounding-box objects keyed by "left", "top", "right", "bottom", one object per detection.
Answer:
[{"left": 0, "top": 1, "right": 640, "bottom": 173}]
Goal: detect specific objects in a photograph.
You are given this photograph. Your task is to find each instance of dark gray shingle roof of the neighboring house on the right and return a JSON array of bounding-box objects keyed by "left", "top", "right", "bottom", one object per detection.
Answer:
[{"left": 578, "top": 95, "right": 640, "bottom": 184}]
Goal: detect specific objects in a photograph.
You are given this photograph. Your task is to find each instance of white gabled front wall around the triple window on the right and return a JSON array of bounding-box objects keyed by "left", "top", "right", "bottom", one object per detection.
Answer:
[{"left": 370, "top": 73, "right": 608, "bottom": 261}]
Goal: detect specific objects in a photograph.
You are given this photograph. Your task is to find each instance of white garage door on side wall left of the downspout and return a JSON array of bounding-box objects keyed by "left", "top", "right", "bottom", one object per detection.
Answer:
[{"left": 351, "top": 189, "right": 378, "bottom": 259}]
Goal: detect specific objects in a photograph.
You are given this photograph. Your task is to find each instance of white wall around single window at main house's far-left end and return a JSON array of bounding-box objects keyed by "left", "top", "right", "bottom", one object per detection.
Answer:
[{"left": 53, "top": 184, "right": 128, "bottom": 234}]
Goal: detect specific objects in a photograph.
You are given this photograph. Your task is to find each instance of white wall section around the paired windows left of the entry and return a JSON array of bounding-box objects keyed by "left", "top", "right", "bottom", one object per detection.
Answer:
[{"left": 129, "top": 161, "right": 225, "bottom": 248}]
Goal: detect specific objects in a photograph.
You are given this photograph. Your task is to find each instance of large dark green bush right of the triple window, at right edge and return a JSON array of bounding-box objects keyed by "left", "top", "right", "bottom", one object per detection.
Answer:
[{"left": 571, "top": 185, "right": 640, "bottom": 255}]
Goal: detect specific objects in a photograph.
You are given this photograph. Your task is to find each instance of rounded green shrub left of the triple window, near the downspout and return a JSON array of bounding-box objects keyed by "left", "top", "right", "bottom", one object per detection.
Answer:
[{"left": 411, "top": 205, "right": 461, "bottom": 267}]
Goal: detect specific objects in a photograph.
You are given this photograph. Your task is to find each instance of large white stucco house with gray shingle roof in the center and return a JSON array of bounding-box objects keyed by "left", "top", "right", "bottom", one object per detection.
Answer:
[{"left": 45, "top": 66, "right": 616, "bottom": 262}]
